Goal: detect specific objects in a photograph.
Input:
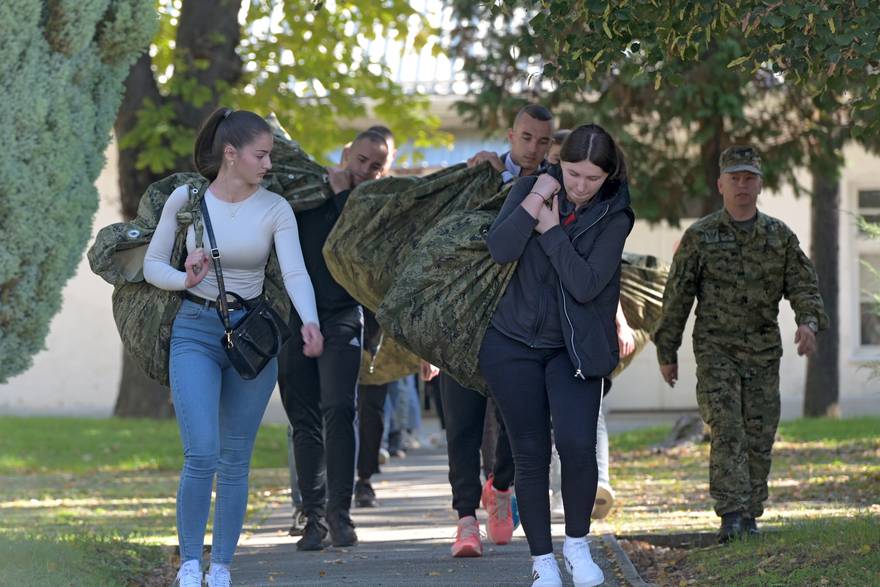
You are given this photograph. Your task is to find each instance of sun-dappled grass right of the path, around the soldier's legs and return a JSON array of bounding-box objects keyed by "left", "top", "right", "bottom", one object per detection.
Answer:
[{"left": 594, "top": 417, "right": 880, "bottom": 587}]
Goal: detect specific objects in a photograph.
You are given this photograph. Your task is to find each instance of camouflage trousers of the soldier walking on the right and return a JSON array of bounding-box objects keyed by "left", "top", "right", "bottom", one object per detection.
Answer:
[{"left": 697, "top": 355, "right": 780, "bottom": 518}]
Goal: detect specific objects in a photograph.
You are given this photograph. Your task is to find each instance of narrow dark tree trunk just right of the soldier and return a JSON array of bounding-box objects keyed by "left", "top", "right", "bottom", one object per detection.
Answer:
[{"left": 804, "top": 164, "right": 840, "bottom": 417}]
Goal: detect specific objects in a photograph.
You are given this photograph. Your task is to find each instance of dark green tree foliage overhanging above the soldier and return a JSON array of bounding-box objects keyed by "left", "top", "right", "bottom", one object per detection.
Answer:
[{"left": 453, "top": 0, "right": 880, "bottom": 222}]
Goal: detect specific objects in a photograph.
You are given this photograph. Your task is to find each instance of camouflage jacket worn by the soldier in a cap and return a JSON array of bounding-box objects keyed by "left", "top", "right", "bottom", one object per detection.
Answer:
[{"left": 652, "top": 208, "right": 828, "bottom": 365}]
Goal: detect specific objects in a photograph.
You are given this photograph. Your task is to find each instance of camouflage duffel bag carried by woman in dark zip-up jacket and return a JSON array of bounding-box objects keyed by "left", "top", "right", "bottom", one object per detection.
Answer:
[{"left": 376, "top": 210, "right": 516, "bottom": 392}]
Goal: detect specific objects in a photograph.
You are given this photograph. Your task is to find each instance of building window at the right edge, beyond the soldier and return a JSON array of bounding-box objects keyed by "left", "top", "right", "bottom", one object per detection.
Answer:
[{"left": 857, "top": 190, "right": 880, "bottom": 346}]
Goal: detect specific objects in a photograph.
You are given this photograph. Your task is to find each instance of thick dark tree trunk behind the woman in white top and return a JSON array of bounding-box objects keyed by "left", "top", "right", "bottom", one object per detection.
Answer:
[{"left": 113, "top": 0, "right": 242, "bottom": 418}]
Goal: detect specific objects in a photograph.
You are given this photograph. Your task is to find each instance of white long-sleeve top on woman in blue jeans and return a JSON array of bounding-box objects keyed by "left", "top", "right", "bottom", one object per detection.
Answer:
[{"left": 144, "top": 185, "right": 320, "bottom": 324}]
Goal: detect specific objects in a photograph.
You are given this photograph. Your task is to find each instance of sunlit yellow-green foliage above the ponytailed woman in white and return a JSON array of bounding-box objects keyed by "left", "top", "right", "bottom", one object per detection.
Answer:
[{"left": 121, "top": 0, "right": 450, "bottom": 174}]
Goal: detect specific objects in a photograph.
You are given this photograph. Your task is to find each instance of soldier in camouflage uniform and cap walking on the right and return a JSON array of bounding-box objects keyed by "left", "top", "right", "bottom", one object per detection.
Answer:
[{"left": 652, "top": 146, "right": 828, "bottom": 542}]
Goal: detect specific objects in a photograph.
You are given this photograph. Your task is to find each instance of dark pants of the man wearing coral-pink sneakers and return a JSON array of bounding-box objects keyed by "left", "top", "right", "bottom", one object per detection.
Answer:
[{"left": 440, "top": 373, "right": 514, "bottom": 518}]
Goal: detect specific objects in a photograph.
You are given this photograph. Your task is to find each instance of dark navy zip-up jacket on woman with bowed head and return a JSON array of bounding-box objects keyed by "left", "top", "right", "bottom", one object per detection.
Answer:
[{"left": 487, "top": 166, "right": 635, "bottom": 379}]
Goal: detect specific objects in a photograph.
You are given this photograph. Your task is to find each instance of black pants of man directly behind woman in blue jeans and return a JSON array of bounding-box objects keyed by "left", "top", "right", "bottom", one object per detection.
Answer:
[{"left": 278, "top": 306, "right": 363, "bottom": 516}]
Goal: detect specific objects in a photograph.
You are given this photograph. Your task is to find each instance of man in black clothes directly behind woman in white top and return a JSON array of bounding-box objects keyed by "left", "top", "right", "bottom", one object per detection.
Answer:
[{"left": 278, "top": 131, "right": 389, "bottom": 550}]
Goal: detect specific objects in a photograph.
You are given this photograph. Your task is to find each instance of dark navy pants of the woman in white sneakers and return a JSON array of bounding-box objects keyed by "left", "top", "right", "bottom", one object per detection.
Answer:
[{"left": 480, "top": 327, "right": 603, "bottom": 556}]
